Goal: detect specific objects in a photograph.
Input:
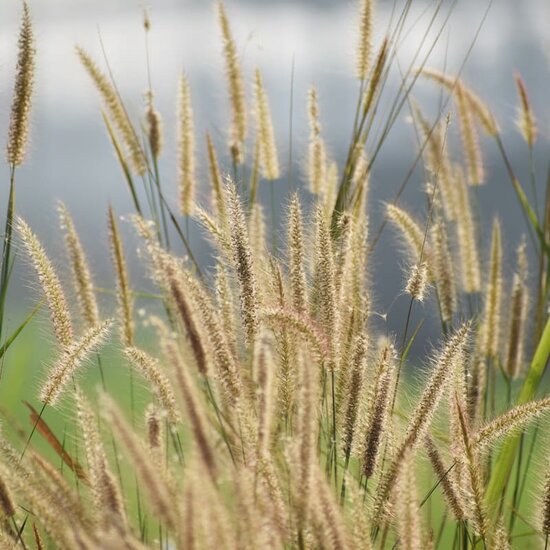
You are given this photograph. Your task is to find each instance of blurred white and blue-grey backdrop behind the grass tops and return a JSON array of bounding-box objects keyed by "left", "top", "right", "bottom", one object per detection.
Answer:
[{"left": 0, "top": 0, "right": 550, "bottom": 362}]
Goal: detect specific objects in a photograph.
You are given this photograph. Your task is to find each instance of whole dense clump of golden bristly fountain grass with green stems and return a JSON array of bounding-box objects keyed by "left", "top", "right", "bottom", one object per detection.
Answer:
[{"left": 0, "top": 0, "right": 550, "bottom": 550}]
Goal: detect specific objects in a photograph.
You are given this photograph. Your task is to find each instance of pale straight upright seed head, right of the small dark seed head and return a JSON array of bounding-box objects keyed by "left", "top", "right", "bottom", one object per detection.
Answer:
[{"left": 177, "top": 75, "right": 196, "bottom": 215}]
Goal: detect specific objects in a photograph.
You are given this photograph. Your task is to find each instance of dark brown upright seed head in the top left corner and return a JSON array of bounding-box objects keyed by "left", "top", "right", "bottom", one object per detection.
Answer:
[{"left": 7, "top": 2, "right": 36, "bottom": 166}]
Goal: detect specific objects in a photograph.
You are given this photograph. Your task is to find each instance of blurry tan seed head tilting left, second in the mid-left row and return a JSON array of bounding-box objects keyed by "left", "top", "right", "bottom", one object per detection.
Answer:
[{"left": 58, "top": 203, "right": 99, "bottom": 328}]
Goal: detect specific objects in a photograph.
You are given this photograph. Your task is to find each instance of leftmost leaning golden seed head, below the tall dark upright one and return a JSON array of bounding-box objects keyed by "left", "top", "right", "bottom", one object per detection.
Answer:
[{"left": 16, "top": 218, "right": 73, "bottom": 349}]
